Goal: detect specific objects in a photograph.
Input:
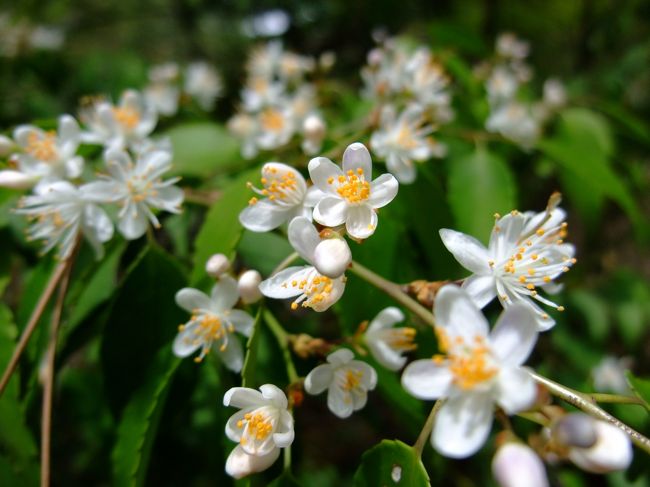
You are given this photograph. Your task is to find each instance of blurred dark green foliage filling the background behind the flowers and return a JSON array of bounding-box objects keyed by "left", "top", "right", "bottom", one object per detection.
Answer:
[{"left": 0, "top": 0, "right": 650, "bottom": 487}]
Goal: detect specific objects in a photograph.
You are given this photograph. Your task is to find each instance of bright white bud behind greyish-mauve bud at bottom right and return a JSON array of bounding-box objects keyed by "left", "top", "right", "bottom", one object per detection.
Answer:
[{"left": 569, "top": 420, "right": 632, "bottom": 473}]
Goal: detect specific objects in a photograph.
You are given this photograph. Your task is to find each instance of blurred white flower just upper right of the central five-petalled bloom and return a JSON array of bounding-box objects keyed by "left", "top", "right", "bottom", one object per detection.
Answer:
[{"left": 370, "top": 105, "right": 446, "bottom": 184}]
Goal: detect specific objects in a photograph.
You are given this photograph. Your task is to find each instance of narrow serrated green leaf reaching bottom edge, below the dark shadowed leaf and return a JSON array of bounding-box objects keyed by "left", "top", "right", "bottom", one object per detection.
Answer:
[{"left": 112, "top": 349, "right": 180, "bottom": 486}]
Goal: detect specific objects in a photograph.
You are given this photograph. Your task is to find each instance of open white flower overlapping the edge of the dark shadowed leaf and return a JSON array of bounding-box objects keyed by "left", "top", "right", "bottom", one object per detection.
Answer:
[{"left": 173, "top": 276, "right": 254, "bottom": 372}]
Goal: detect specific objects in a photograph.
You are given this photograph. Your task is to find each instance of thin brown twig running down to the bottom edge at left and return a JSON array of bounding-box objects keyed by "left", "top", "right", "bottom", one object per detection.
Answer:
[{"left": 41, "top": 254, "right": 74, "bottom": 487}]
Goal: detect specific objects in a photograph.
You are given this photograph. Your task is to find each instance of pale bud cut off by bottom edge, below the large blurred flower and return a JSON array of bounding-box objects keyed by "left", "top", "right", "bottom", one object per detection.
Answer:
[{"left": 492, "top": 442, "right": 548, "bottom": 487}]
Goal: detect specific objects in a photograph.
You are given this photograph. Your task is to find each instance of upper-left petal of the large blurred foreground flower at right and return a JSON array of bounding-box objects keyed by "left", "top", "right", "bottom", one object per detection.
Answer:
[{"left": 433, "top": 284, "right": 488, "bottom": 343}]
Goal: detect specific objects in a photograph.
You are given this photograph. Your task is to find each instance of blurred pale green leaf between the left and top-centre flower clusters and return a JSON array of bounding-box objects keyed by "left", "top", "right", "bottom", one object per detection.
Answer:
[{"left": 165, "top": 123, "right": 244, "bottom": 178}]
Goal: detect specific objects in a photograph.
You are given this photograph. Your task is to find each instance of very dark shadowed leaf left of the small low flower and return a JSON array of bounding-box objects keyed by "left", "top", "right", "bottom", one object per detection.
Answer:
[{"left": 101, "top": 247, "right": 187, "bottom": 413}]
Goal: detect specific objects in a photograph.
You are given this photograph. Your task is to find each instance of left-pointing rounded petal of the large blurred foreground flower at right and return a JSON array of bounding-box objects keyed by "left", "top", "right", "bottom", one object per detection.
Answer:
[{"left": 402, "top": 359, "right": 453, "bottom": 399}]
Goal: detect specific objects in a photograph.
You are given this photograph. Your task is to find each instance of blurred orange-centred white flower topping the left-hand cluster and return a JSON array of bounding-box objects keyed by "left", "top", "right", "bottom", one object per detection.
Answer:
[{"left": 80, "top": 90, "right": 158, "bottom": 150}]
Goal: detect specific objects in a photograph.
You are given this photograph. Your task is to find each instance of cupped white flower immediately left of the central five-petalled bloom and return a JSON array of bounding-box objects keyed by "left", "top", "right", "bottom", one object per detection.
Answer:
[{"left": 239, "top": 162, "right": 319, "bottom": 232}]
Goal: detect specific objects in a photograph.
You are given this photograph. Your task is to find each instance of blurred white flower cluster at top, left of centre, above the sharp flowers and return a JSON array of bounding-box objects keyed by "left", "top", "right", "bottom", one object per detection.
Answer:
[{"left": 228, "top": 41, "right": 325, "bottom": 158}]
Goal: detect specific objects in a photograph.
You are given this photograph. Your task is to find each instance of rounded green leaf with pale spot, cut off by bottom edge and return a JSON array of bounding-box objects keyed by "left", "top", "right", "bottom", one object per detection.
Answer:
[{"left": 354, "top": 440, "right": 430, "bottom": 487}]
